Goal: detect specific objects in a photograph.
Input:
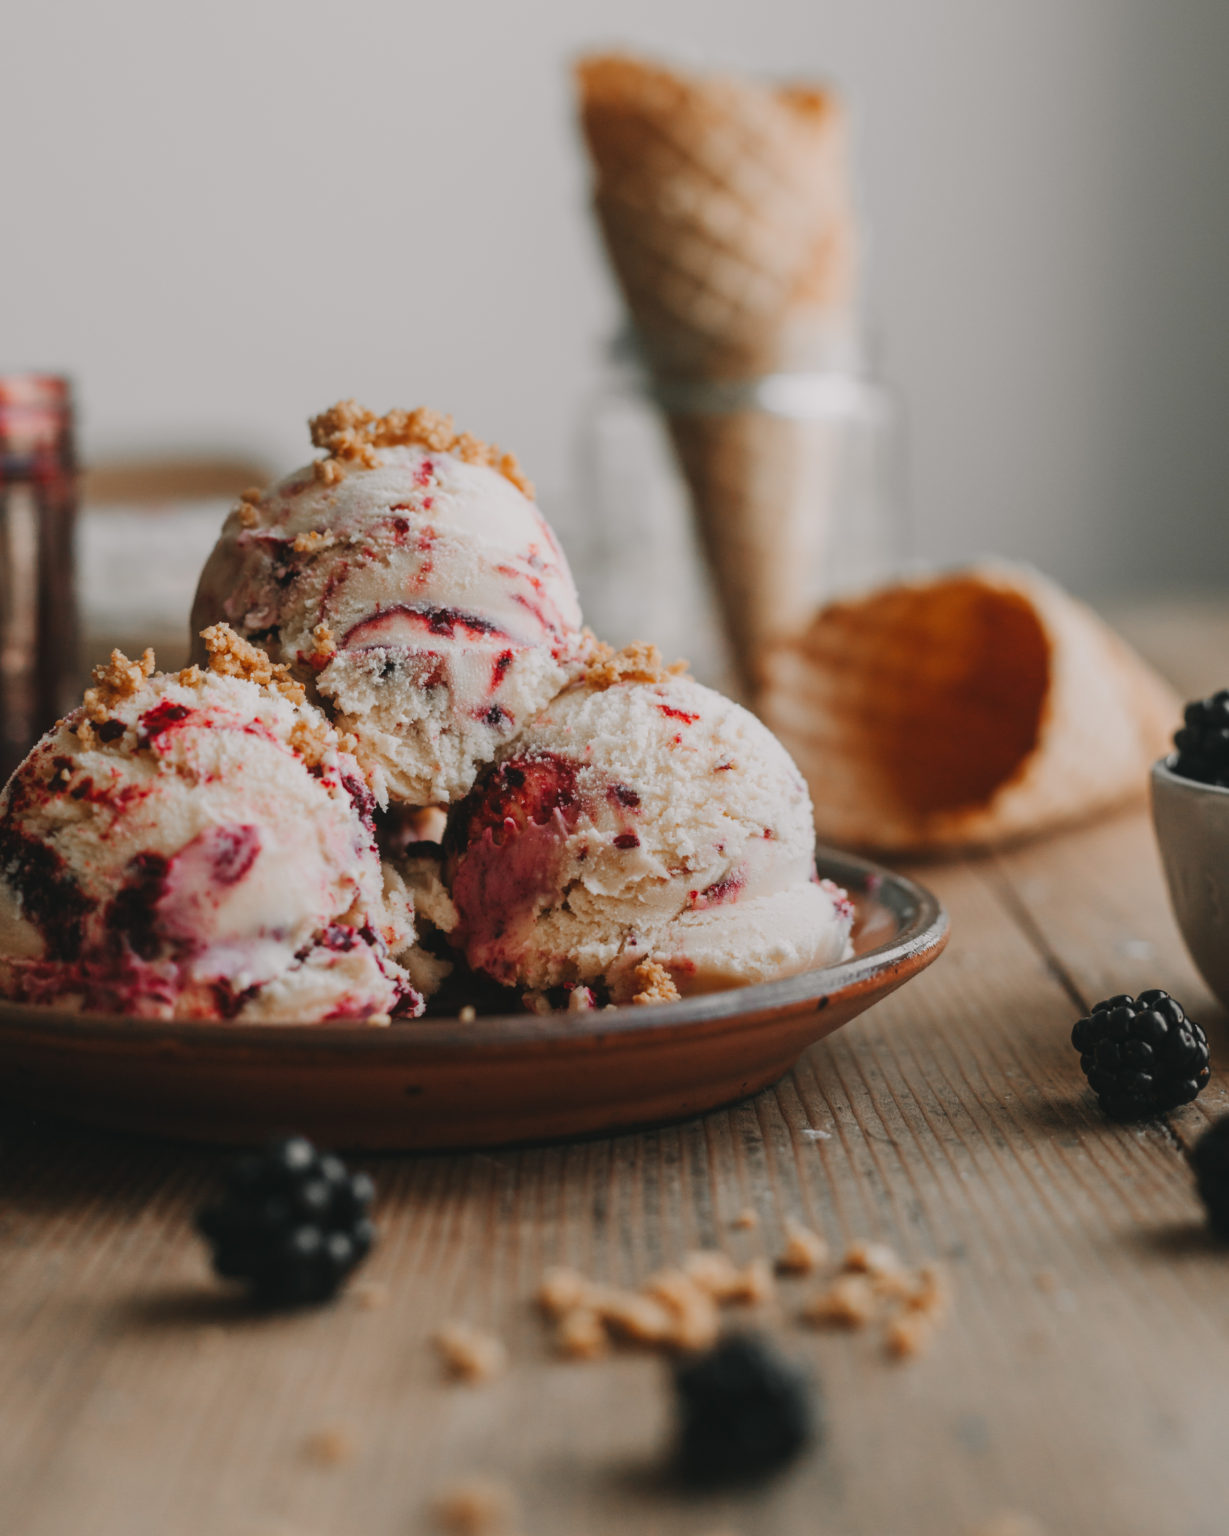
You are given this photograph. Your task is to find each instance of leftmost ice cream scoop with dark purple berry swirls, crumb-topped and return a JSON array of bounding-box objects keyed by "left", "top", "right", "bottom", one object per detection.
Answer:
[{"left": 0, "top": 627, "right": 422, "bottom": 1023}]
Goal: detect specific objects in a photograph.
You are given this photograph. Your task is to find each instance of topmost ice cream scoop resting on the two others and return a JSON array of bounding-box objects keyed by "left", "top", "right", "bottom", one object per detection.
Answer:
[{"left": 192, "top": 404, "right": 582, "bottom": 805}]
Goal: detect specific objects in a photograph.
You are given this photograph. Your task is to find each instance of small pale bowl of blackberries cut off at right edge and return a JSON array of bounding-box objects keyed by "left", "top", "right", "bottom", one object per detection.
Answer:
[{"left": 1152, "top": 688, "right": 1229, "bottom": 1008}]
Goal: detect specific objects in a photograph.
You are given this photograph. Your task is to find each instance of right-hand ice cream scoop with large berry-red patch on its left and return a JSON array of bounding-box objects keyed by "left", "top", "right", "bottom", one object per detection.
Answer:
[{"left": 444, "top": 647, "right": 853, "bottom": 1001}]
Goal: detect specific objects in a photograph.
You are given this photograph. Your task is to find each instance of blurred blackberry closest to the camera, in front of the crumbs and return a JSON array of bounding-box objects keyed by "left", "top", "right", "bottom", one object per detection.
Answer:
[{"left": 674, "top": 1333, "right": 814, "bottom": 1485}]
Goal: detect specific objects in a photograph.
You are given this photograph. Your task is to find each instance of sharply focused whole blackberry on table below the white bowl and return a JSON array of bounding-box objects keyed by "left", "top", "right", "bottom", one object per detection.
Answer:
[{"left": 1071, "top": 989, "right": 1211, "bottom": 1120}]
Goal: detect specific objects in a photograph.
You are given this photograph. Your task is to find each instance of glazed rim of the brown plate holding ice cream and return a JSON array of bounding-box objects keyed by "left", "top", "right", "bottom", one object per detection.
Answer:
[{"left": 0, "top": 845, "right": 949, "bottom": 1060}]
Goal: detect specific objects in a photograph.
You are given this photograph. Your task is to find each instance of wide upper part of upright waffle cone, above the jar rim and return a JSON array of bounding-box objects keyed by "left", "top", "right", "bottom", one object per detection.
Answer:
[{"left": 576, "top": 54, "right": 854, "bottom": 378}]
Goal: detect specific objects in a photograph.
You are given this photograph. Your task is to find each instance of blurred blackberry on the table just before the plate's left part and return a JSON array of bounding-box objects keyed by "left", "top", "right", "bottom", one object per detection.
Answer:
[{"left": 197, "top": 1137, "right": 375, "bottom": 1307}]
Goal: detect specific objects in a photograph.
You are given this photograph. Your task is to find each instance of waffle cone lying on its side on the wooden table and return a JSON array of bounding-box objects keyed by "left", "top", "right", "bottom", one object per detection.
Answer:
[{"left": 759, "top": 565, "right": 1181, "bottom": 851}]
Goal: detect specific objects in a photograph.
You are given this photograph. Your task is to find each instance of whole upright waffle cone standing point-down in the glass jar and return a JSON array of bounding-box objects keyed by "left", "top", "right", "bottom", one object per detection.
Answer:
[{"left": 576, "top": 55, "right": 856, "bottom": 682}]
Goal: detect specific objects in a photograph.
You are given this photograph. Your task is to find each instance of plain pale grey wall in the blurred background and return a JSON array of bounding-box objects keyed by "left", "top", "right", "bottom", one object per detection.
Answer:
[{"left": 0, "top": 0, "right": 1229, "bottom": 593}]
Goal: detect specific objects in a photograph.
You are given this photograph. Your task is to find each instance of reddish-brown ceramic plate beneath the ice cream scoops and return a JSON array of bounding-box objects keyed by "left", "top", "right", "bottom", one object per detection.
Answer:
[{"left": 0, "top": 849, "right": 948, "bottom": 1147}]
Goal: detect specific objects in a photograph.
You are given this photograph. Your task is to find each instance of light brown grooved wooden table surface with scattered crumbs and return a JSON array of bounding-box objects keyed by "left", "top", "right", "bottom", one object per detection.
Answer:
[{"left": 0, "top": 605, "right": 1229, "bottom": 1536}]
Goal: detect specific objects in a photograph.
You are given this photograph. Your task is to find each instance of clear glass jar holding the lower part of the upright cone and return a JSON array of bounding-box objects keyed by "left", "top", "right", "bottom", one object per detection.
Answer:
[{"left": 564, "top": 338, "right": 908, "bottom": 697}]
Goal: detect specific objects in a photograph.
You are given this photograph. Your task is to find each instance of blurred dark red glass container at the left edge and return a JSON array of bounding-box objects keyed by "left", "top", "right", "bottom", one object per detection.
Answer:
[{"left": 0, "top": 373, "right": 77, "bottom": 780}]
